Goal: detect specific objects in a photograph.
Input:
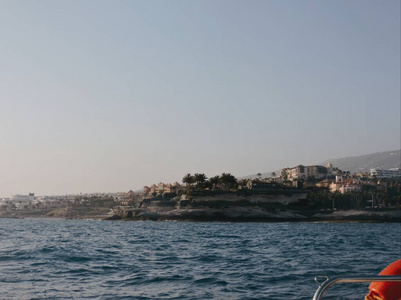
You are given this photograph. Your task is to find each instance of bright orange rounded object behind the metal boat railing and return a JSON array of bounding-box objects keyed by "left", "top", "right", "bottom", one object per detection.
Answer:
[{"left": 365, "top": 259, "right": 401, "bottom": 300}]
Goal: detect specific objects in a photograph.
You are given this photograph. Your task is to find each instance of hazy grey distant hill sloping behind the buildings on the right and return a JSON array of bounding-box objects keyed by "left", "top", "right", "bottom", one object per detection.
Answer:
[{"left": 320, "top": 150, "right": 401, "bottom": 173}]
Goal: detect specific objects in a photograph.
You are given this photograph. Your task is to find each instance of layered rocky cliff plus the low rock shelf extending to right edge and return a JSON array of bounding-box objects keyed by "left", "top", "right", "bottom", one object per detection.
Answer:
[{"left": 108, "top": 192, "right": 401, "bottom": 222}]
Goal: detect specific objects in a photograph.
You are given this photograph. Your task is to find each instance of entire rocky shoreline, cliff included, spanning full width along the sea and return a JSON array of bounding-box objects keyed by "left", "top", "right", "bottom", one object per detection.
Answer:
[{"left": 0, "top": 193, "right": 401, "bottom": 223}]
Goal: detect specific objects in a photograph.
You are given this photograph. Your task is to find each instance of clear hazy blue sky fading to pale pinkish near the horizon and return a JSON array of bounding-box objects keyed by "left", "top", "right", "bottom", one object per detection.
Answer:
[{"left": 0, "top": 0, "right": 401, "bottom": 197}]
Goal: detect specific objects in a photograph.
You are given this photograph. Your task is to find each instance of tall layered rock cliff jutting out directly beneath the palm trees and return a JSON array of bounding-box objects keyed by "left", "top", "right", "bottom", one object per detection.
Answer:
[{"left": 109, "top": 193, "right": 306, "bottom": 221}]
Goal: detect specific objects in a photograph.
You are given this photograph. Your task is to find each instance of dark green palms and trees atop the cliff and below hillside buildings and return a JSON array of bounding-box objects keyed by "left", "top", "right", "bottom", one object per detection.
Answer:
[{"left": 182, "top": 172, "right": 401, "bottom": 210}]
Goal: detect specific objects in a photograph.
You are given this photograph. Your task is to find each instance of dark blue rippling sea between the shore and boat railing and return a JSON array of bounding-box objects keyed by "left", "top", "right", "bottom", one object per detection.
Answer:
[{"left": 0, "top": 219, "right": 401, "bottom": 300}]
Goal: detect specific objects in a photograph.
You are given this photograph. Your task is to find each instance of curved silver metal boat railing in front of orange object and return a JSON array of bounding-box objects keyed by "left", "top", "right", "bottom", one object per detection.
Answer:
[{"left": 313, "top": 276, "right": 401, "bottom": 300}]
